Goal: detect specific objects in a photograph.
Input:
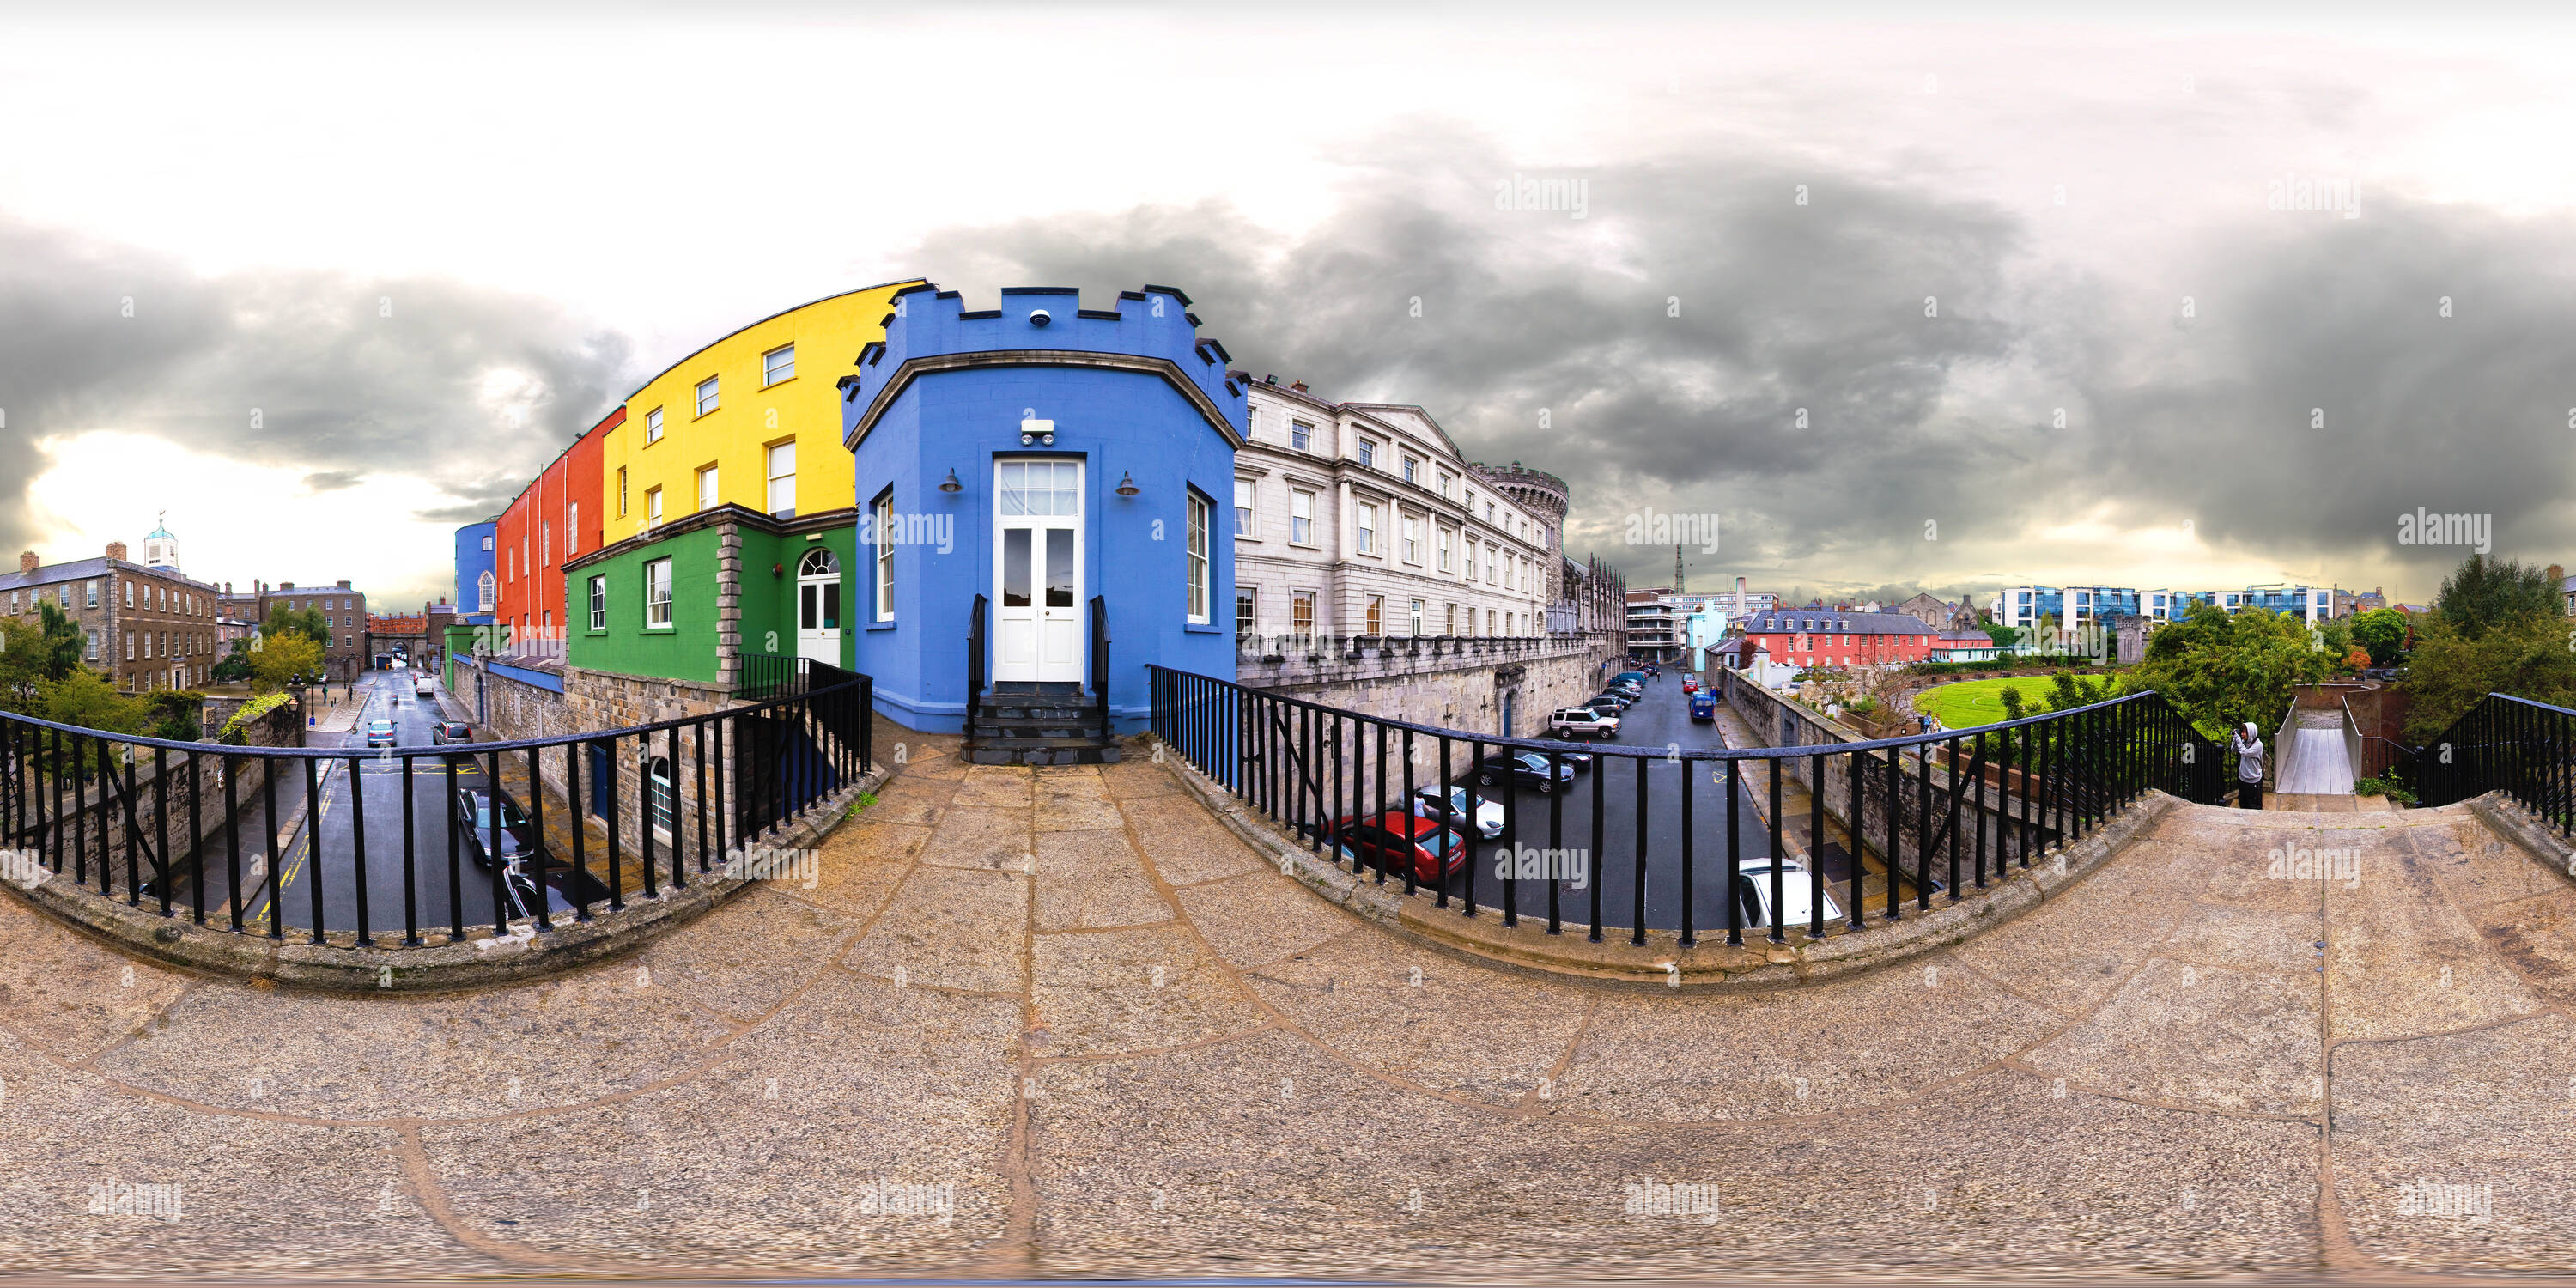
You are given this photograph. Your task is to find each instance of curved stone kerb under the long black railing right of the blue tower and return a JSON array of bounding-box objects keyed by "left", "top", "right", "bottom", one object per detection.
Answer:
[{"left": 1154, "top": 739, "right": 2182, "bottom": 992}]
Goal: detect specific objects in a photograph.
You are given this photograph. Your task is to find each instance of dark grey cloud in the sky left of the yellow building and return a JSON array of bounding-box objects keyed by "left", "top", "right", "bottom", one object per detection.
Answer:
[{"left": 0, "top": 222, "right": 626, "bottom": 546}]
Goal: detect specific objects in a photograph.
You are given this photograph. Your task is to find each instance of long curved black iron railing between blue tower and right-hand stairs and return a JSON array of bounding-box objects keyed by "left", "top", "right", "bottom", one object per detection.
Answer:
[{"left": 1151, "top": 667, "right": 2226, "bottom": 945}]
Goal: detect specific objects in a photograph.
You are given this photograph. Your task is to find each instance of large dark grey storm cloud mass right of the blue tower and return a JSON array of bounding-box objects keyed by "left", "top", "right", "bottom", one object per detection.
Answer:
[{"left": 914, "top": 126, "right": 2576, "bottom": 598}]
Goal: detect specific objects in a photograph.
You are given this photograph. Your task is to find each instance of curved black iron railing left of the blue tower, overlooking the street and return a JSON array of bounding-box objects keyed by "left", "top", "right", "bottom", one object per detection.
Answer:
[{"left": 0, "top": 667, "right": 873, "bottom": 948}]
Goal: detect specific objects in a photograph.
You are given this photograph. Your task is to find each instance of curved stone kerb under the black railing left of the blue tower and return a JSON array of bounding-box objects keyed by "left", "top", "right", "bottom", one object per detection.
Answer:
[{"left": 10, "top": 768, "right": 891, "bottom": 992}]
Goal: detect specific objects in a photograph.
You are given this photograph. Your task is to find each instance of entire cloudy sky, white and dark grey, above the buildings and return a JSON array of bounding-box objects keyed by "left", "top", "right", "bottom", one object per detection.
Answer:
[{"left": 0, "top": 5, "right": 2576, "bottom": 603}]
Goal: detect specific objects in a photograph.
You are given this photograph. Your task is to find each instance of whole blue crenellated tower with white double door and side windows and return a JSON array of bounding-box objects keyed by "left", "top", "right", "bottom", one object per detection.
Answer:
[{"left": 842, "top": 286, "right": 1247, "bottom": 760}]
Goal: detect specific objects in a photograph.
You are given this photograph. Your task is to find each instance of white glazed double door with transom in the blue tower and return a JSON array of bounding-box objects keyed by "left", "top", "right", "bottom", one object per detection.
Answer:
[{"left": 992, "top": 461, "right": 1084, "bottom": 683}]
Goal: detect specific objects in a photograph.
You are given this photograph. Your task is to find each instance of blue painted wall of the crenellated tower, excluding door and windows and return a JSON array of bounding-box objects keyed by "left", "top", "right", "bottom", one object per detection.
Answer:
[{"left": 842, "top": 286, "right": 1244, "bottom": 732}]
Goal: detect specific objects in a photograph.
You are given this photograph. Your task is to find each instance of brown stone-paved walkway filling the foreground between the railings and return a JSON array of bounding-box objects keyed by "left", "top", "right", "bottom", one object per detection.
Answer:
[{"left": 0, "top": 742, "right": 2576, "bottom": 1280}]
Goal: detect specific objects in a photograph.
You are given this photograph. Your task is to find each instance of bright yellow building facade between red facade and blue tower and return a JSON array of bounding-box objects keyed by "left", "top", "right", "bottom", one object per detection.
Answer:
[{"left": 600, "top": 281, "right": 917, "bottom": 544}]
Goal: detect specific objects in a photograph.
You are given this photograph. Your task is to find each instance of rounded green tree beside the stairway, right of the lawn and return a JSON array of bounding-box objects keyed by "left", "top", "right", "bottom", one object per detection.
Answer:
[{"left": 2128, "top": 603, "right": 2339, "bottom": 742}]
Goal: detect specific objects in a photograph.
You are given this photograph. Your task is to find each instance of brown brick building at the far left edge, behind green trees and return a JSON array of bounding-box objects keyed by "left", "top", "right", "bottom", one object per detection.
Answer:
[{"left": 0, "top": 541, "right": 224, "bottom": 693}]
